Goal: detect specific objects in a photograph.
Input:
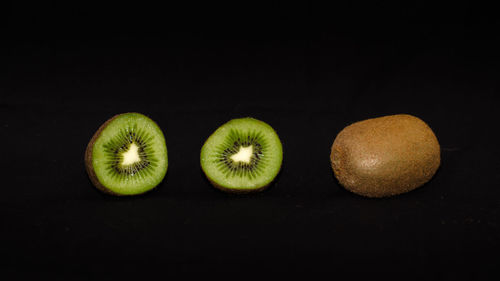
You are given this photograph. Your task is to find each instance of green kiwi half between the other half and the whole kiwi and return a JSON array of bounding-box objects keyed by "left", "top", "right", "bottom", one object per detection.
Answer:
[{"left": 200, "top": 117, "right": 283, "bottom": 193}]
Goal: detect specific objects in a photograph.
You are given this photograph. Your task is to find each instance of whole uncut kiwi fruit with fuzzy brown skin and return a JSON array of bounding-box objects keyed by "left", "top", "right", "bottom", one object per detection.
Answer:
[{"left": 330, "top": 114, "right": 441, "bottom": 197}]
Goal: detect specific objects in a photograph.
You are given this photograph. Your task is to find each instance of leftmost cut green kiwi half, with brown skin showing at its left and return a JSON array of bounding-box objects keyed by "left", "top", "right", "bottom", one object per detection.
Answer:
[{"left": 85, "top": 113, "right": 168, "bottom": 196}]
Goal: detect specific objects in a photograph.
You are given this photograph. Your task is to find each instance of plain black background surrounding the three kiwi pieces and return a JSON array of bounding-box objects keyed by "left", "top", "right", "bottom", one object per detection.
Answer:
[{"left": 0, "top": 1, "right": 500, "bottom": 280}]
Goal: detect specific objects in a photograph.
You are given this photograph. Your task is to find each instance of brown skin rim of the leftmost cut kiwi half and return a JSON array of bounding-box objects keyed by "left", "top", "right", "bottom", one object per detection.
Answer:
[{"left": 85, "top": 112, "right": 164, "bottom": 196}]
